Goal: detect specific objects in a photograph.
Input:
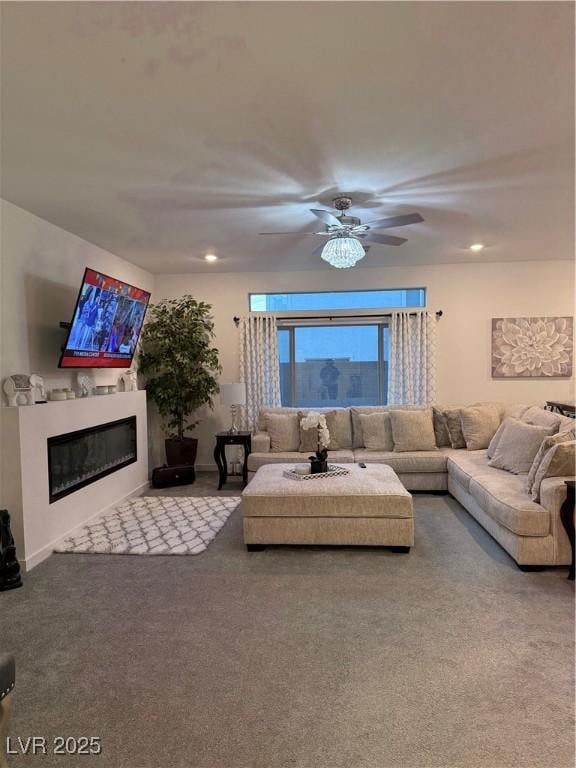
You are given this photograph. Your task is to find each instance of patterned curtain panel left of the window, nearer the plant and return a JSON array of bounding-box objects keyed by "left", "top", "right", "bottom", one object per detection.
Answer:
[{"left": 240, "top": 315, "right": 281, "bottom": 432}]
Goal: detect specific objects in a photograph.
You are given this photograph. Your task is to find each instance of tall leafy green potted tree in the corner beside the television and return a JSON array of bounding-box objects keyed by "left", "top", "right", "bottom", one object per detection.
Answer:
[{"left": 138, "top": 296, "right": 222, "bottom": 466}]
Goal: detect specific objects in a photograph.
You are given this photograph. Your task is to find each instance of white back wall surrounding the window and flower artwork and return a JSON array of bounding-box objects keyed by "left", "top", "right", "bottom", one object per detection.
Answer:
[{"left": 156, "top": 261, "right": 574, "bottom": 464}]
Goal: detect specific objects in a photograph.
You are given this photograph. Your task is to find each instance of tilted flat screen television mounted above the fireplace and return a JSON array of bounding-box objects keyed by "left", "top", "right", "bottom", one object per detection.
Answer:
[{"left": 59, "top": 269, "right": 150, "bottom": 368}]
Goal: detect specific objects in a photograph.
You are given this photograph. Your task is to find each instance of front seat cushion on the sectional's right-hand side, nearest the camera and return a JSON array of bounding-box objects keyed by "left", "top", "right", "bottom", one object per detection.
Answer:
[{"left": 470, "top": 472, "right": 550, "bottom": 536}]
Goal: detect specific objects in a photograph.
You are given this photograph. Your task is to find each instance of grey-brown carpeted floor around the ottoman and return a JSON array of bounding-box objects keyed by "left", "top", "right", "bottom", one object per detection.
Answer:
[{"left": 0, "top": 476, "right": 574, "bottom": 768}]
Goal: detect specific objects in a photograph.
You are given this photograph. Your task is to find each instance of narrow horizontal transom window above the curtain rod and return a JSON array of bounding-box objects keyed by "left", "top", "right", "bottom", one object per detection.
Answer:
[{"left": 248, "top": 288, "right": 426, "bottom": 312}]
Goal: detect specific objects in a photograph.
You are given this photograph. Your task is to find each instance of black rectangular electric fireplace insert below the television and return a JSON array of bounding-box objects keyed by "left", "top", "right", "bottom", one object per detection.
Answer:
[{"left": 48, "top": 416, "right": 138, "bottom": 504}]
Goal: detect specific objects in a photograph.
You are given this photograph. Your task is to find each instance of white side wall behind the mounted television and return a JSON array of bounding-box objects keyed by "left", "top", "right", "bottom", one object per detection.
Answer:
[{"left": 0, "top": 200, "right": 154, "bottom": 390}]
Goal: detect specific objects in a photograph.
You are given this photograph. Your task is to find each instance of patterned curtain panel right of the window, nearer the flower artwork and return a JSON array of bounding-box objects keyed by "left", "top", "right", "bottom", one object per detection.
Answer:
[{"left": 388, "top": 312, "right": 437, "bottom": 405}]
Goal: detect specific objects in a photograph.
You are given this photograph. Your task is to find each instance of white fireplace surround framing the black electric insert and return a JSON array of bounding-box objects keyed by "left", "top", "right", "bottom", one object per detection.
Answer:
[{"left": 0, "top": 390, "right": 148, "bottom": 570}]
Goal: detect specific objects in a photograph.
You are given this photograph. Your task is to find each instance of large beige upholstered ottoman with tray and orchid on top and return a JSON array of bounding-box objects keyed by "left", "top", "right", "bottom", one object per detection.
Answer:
[{"left": 242, "top": 464, "right": 414, "bottom": 552}]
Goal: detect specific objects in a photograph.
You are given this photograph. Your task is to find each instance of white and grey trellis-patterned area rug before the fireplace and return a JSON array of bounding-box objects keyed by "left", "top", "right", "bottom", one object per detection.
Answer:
[{"left": 54, "top": 496, "right": 240, "bottom": 555}]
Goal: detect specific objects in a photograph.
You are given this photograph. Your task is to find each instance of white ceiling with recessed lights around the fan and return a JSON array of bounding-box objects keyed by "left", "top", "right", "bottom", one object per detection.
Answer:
[{"left": 1, "top": 2, "right": 574, "bottom": 272}]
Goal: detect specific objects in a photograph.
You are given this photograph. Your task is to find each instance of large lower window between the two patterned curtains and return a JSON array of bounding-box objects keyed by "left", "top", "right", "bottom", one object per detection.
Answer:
[{"left": 278, "top": 323, "right": 389, "bottom": 408}]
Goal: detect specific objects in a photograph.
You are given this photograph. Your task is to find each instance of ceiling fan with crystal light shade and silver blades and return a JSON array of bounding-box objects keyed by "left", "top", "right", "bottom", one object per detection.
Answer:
[{"left": 260, "top": 197, "right": 424, "bottom": 267}]
